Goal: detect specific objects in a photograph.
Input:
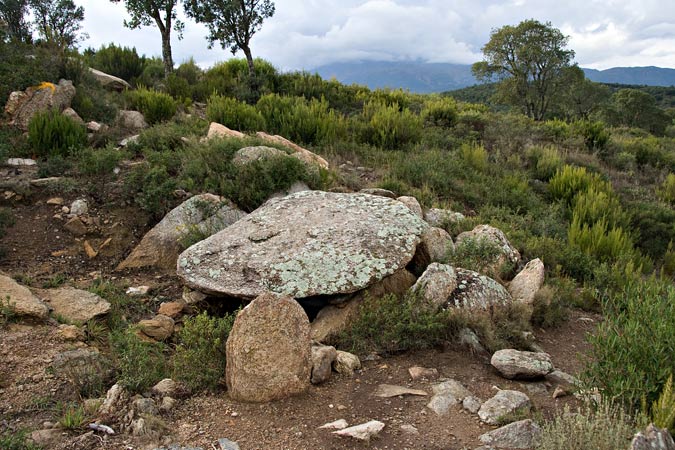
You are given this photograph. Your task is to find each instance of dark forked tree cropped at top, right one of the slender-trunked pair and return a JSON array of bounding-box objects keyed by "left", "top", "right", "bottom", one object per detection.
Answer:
[{"left": 185, "top": 0, "right": 275, "bottom": 78}]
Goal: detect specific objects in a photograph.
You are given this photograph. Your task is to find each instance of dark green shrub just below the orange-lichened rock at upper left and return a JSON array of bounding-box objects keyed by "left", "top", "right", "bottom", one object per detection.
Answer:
[{"left": 28, "top": 110, "right": 87, "bottom": 158}]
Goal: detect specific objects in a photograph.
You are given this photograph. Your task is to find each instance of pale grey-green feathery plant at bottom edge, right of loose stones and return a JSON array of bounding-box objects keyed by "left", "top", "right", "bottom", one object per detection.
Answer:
[{"left": 535, "top": 403, "right": 635, "bottom": 450}]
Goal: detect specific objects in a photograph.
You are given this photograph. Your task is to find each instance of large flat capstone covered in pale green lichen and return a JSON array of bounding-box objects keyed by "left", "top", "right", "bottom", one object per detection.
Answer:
[{"left": 177, "top": 191, "right": 427, "bottom": 299}]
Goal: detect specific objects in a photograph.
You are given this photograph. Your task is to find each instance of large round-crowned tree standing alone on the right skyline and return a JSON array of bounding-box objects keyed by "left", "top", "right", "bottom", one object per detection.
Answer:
[{"left": 472, "top": 19, "right": 574, "bottom": 120}]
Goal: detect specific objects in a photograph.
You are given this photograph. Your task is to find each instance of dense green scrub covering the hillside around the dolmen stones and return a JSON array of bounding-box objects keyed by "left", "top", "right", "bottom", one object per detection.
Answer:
[{"left": 0, "top": 16, "right": 675, "bottom": 448}]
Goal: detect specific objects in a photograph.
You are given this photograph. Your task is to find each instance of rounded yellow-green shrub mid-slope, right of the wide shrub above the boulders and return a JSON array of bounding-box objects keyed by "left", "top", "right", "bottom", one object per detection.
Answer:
[{"left": 362, "top": 100, "right": 422, "bottom": 149}]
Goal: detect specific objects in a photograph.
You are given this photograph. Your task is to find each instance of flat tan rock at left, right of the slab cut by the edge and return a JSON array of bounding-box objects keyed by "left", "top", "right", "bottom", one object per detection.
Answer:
[{"left": 36, "top": 286, "right": 110, "bottom": 323}]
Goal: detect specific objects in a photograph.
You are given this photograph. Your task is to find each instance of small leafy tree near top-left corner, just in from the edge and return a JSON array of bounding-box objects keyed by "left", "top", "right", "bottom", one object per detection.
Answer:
[{"left": 30, "top": 0, "right": 86, "bottom": 52}]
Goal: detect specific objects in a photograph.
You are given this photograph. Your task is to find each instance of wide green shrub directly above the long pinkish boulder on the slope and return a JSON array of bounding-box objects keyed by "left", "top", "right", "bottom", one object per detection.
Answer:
[{"left": 256, "top": 94, "right": 344, "bottom": 144}]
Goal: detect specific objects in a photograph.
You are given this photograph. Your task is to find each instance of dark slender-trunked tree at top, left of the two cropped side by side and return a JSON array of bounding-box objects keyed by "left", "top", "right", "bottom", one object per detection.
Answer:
[{"left": 110, "top": 0, "right": 185, "bottom": 77}]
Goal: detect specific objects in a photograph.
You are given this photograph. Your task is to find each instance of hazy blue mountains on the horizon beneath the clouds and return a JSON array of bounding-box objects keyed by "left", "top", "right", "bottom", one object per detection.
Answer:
[{"left": 314, "top": 61, "right": 675, "bottom": 94}]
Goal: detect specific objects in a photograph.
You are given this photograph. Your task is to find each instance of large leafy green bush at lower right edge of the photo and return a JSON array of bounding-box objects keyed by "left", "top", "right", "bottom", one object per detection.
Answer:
[{"left": 584, "top": 279, "right": 675, "bottom": 411}]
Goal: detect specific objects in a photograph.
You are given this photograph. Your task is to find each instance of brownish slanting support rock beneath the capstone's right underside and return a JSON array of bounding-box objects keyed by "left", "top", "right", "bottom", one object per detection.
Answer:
[{"left": 311, "top": 269, "right": 415, "bottom": 342}]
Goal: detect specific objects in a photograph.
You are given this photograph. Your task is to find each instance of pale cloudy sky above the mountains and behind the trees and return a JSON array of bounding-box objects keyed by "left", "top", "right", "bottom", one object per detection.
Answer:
[{"left": 75, "top": 0, "right": 675, "bottom": 70}]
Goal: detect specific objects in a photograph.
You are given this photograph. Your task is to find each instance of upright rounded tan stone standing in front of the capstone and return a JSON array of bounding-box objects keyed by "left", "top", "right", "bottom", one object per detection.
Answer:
[{"left": 226, "top": 292, "right": 312, "bottom": 402}]
